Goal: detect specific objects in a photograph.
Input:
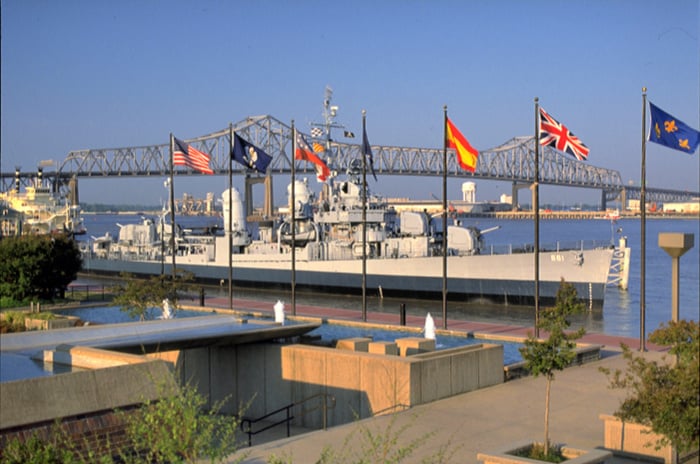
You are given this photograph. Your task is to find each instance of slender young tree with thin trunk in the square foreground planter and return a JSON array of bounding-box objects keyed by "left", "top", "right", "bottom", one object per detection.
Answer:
[{"left": 520, "top": 279, "right": 585, "bottom": 458}]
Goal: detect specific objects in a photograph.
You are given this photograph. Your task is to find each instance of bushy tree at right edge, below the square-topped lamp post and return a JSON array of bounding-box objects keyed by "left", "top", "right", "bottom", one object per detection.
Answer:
[{"left": 602, "top": 320, "right": 700, "bottom": 452}]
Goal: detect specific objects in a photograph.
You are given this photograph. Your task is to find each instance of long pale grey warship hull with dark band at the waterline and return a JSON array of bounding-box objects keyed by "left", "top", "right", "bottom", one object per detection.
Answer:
[{"left": 83, "top": 249, "right": 613, "bottom": 309}]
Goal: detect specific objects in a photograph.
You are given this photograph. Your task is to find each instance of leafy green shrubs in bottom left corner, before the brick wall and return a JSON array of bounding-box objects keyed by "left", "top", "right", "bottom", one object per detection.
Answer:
[{"left": 0, "top": 386, "right": 245, "bottom": 464}]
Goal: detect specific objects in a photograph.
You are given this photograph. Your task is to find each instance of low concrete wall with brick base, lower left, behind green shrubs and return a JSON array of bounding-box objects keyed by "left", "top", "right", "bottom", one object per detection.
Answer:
[{"left": 0, "top": 345, "right": 177, "bottom": 454}]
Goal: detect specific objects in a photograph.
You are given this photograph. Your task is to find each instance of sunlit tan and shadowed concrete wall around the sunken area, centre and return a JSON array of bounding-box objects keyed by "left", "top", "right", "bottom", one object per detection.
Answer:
[{"left": 158, "top": 343, "right": 503, "bottom": 428}]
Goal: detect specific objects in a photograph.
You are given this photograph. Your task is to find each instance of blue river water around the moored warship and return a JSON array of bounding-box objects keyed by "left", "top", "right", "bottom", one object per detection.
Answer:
[{"left": 81, "top": 214, "right": 700, "bottom": 337}]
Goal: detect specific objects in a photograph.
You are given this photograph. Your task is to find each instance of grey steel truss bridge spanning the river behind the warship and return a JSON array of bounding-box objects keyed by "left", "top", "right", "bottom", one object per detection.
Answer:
[{"left": 1, "top": 115, "right": 700, "bottom": 209}]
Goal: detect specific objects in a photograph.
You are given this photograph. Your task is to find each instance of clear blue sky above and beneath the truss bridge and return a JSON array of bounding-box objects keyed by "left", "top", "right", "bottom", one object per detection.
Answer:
[{"left": 1, "top": 0, "right": 700, "bottom": 204}]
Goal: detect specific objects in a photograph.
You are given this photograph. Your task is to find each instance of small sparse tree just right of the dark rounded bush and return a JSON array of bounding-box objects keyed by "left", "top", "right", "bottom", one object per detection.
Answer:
[{"left": 112, "top": 272, "right": 193, "bottom": 321}]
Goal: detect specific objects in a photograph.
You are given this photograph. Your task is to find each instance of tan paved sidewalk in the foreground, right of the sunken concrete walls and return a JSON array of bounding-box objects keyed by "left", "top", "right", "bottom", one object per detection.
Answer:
[{"left": 230, "top": 352, "right": 662, "bottom": 464}]
